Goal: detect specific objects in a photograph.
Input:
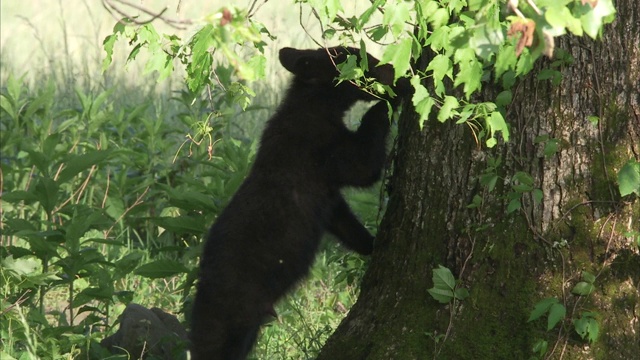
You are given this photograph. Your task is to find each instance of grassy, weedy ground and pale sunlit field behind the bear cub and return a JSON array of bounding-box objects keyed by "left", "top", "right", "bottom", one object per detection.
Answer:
[{"left": 0, "top": 0, "right": 377, "bottom": 359}]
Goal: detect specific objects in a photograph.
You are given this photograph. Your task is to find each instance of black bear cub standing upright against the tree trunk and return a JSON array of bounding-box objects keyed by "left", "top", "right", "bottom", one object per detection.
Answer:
[{"left": 191, "top": 47, "right": 404, "bottom": 360}]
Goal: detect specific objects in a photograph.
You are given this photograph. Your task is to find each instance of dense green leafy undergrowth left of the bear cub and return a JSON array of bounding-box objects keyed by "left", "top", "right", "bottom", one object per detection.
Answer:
[{"left": 0, "top": 67, "right": 264, "bottom": 359}]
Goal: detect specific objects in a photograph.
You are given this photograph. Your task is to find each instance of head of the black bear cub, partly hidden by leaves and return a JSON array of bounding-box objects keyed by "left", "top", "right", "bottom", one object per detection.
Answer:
[{"left": 280, "top": 46, "right": 394, "bottom": 100}]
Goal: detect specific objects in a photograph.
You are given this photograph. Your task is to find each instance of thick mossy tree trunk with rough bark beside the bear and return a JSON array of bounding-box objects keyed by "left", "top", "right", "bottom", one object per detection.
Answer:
[{"left": 319, "top": 0, "right": 640, "bottom": 360}]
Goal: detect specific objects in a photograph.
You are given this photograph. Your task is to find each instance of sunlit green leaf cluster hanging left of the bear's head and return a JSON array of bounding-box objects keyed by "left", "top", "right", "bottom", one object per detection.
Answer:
[{"left": 102, "top": 8, "right": 270, "bottom": 102}]
